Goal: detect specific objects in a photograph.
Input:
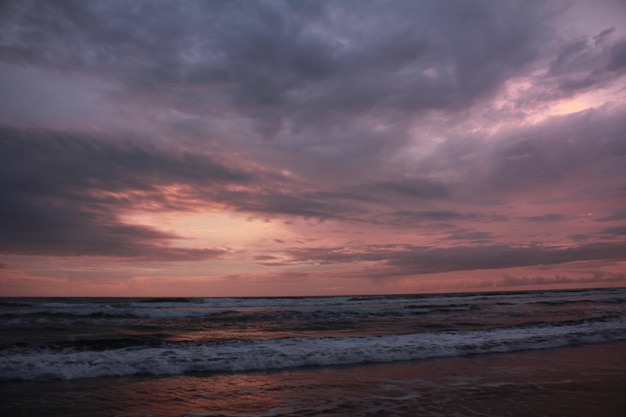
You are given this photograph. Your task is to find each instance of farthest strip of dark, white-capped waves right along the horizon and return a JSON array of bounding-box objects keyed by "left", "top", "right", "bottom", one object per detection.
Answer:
[{"left": 0, "top": 288, "right": 626, "bottom": 318}]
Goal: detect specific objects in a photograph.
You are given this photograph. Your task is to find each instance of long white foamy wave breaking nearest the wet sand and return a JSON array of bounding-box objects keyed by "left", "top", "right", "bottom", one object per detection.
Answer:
[{"left": 0, "top": 316, "right": 626, "bottom": 380}]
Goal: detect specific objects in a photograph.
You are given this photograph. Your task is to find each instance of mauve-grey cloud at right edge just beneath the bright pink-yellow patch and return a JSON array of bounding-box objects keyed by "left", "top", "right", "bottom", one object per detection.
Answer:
[{"left": 472, "top": 109, "right": 626, "bottom": 198}]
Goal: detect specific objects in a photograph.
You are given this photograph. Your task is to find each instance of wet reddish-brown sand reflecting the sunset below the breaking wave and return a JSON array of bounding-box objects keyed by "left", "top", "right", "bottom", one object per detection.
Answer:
[{"left": 0, "top": 342, "right": 626, "bottom": 417}]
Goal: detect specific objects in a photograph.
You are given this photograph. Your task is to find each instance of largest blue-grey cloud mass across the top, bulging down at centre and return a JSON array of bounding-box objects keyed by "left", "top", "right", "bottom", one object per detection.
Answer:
[{"left": 0, "top": 0, "right": 550, "bottom": 177}]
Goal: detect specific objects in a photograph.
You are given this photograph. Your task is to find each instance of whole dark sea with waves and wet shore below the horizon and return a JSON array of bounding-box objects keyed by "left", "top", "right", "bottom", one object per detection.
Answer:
[{"left": 0, "top": 288, "right": 626, "bottom": 417}]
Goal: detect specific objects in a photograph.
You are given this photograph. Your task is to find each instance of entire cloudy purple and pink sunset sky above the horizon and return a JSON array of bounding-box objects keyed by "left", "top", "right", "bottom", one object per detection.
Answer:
[{"left": 0, "top": 0, "right": 626, "bottom": 297}]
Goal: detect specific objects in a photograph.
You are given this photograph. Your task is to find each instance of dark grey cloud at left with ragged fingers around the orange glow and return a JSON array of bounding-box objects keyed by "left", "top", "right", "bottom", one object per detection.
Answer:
[{"left": 0, "top": 128, "right": 250, "bottom": 260}]
